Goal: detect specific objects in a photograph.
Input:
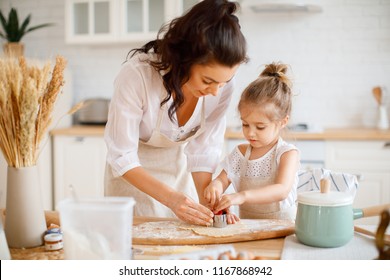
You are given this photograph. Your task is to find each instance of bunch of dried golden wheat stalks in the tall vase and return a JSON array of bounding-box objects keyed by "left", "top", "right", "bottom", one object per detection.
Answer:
[{"left": 0, "top": 56, "right": 66, "bottom": 167}]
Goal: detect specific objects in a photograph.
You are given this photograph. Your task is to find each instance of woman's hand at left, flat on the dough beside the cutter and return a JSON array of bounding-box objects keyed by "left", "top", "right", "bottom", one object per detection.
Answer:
[{"left": 168, "top": 192, "right": 214, "bottom": 226}]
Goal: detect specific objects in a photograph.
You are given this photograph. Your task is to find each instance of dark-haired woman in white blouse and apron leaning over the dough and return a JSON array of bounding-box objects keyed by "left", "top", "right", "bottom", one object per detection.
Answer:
[{"left": 105, "top": 0, "right": 247, "bottom": 225}]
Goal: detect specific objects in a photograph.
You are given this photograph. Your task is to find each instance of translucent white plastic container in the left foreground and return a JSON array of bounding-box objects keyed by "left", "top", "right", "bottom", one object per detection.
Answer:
[{"left": 58, "top": 197, "right": 135, "bottom": 260}]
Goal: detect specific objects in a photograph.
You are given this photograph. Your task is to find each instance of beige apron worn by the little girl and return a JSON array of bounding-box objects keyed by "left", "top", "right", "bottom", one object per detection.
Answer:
[{"left": 238, "top": 145, "right": 296, "bottom": 220}]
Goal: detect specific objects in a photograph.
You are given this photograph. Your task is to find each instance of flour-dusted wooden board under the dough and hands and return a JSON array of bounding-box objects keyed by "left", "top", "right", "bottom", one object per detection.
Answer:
[{"left": 132, "top": 219, "right": 295, "bottom": 245}]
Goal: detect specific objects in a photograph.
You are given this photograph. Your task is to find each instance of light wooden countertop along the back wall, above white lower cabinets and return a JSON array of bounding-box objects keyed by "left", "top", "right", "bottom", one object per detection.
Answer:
[{"left": 50, "top": 125, "right": 390, "bottom": 141}]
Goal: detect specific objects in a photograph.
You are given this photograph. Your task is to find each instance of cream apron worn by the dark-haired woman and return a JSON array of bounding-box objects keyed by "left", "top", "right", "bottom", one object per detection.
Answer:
[{"left": 104, "top": 99, "right": 205, "bottom": 217}]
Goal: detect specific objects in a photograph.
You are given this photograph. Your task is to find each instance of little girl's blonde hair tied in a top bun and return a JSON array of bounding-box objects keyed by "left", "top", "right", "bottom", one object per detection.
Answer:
[{"left": 238, "top": 62, "right": 292, "bottom": 121}]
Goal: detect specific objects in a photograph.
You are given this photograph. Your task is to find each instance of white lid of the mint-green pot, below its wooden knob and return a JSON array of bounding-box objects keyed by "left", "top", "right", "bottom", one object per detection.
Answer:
[{"left": 298, "top": 191, "right": 353, "bottom": 206}]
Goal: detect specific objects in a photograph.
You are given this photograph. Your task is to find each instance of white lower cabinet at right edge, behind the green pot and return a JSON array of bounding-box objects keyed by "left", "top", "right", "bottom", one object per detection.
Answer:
[{"left": 326, "top": 141, "right": 390, "bottom": 224}]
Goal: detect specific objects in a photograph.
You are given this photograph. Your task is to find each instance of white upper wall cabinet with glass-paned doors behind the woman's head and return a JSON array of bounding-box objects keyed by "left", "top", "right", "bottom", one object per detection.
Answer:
[{"left": 65, "top": 0, "right": 199, "bottom": 44}]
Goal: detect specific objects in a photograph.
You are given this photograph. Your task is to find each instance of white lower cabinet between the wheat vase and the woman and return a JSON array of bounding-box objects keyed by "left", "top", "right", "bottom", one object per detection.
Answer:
[{"left": 53, "top": 135, "right": 107, "bottom": 207}]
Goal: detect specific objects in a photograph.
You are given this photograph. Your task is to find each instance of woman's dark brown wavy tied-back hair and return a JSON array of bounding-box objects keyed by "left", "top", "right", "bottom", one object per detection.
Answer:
[{"left": 128, "top": 0, "right": 248, "bottom": 119}]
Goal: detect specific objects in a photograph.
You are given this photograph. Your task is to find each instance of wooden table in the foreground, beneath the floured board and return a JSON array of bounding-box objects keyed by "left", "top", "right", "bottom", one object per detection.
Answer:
[{"left": 6, "top": 211, "right": 284, "bottom": 260}]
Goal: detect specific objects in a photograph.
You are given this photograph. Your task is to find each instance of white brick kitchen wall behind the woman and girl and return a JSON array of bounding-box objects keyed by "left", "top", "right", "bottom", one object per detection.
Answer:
[{"left": 0, "top": 0, "right": 390, "bottom": 127}]
